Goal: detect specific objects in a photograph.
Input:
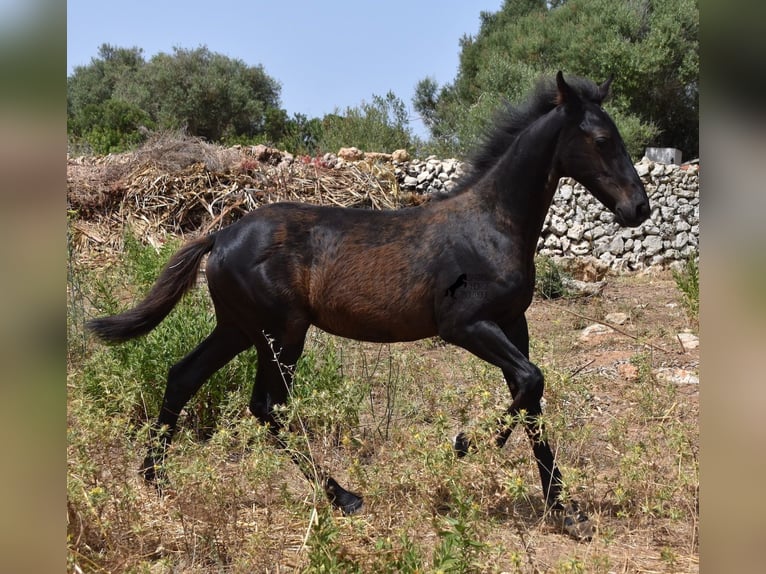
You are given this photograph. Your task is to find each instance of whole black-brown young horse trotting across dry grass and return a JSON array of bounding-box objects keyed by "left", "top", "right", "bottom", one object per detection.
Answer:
[{"left": 88, "top": 72, "right": 650, "bottom": 537}]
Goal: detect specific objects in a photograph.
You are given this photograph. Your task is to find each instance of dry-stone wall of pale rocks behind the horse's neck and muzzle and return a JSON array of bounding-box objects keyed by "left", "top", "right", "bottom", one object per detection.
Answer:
[{"left": 396, "top": 156, "right": 699, "bottom": 271}]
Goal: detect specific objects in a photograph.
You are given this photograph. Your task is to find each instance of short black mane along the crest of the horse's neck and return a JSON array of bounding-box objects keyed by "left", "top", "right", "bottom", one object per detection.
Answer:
[{"left": 443, "top": 76, "right": 602, "bottom": 197}]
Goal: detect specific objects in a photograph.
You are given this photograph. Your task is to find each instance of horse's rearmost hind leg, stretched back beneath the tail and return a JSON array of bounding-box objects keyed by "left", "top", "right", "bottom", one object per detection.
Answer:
[{"left": 141, "top": 324, "right": 251, "bottom": 487}]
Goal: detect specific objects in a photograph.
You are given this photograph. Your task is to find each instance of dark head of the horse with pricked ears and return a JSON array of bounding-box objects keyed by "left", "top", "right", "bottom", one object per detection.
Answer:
[{"left": 556, "top": 72, "right": 651, "bottom": 227}]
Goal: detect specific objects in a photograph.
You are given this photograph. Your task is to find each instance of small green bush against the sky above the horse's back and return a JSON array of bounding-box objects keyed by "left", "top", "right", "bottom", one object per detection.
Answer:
[{"left": 318, "top": 92, "right": 413, "bottom": 152}]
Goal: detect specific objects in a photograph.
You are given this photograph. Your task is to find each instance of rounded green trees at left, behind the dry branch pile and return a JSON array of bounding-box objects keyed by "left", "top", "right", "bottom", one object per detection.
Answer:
[{"left": 67, "top": 44, "right": 281, "bottom": 153}]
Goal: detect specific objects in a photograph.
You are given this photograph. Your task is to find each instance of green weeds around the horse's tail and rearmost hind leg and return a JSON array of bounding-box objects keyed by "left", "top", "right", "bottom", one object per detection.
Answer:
[{"left": 77, "top": 234, "right": 256, "bottom": 437}]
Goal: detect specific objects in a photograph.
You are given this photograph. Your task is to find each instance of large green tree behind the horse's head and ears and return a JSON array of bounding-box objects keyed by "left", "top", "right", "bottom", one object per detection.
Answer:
[{"left": 413, "top": 0, "right": 699, "bottom": 159}]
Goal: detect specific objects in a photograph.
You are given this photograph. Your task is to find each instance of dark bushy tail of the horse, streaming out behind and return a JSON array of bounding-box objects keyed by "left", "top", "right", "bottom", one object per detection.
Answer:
[{"left": 85, "top": 234, "right": 215, "bottom": 343}]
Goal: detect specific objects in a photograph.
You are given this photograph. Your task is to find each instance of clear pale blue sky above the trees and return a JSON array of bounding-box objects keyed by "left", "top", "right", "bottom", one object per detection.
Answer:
[{"left": 67, "top": 0, "right": 503, "bottom": 135}]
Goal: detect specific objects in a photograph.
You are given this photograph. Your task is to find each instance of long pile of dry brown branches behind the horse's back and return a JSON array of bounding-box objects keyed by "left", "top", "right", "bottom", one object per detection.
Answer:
[{"left": 67, "top": 134, "right": 423, "bottom": 260}]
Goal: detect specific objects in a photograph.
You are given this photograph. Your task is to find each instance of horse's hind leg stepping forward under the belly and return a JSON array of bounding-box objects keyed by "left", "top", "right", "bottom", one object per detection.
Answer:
[{"left": 250, "top": 338, "right": 362, "bottom": 514}]
